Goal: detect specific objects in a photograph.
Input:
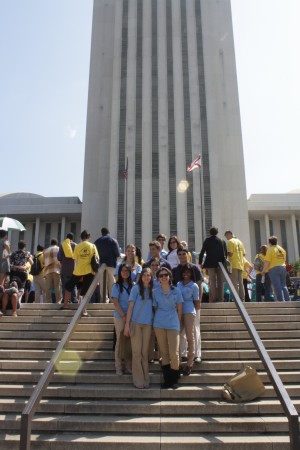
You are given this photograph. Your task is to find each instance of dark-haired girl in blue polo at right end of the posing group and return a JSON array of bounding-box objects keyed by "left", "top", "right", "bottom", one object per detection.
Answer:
[{"left": 177, "top": 264, "right": 200, "bottom": 375}]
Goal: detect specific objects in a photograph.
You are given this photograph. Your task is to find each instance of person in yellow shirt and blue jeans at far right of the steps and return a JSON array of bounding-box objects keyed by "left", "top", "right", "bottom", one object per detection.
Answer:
[{"left": 262, "top": 236, "right": 290, "bottom": 302}]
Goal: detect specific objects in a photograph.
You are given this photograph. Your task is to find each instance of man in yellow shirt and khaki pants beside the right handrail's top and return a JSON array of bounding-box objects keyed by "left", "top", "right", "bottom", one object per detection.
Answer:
[{"left": 225, "top": 230, "right": 246, "bottom": 302}]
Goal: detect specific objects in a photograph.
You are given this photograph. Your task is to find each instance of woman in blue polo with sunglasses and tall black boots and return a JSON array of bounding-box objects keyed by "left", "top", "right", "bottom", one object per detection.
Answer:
[{"left": 153, "top": 267, "right": 183, "bottom": 389}]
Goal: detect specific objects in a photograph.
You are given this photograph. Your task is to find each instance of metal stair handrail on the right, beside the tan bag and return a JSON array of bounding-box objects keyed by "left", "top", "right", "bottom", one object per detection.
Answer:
[{"left": 219, "top": 262, "right": 300, "bottom": 450}]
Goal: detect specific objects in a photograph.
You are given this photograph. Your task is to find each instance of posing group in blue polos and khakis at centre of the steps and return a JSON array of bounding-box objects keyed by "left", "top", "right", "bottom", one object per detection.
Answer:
[{"left": 112, "top": 246, "right": 200, "bottom": 389}]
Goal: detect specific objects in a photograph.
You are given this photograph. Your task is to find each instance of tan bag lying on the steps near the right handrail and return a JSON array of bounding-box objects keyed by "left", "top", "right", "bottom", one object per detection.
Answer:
[{"left": 222, "top": 366, "right": 266, "bottom": 403}]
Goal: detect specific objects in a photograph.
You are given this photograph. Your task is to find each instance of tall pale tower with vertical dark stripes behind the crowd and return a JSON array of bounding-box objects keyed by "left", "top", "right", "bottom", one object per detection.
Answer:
[{"left": 82, "top": 0, "right": 250, "bottom": 254}]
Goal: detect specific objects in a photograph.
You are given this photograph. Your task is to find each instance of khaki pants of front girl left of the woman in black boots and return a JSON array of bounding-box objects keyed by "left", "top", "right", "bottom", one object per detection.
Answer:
[{"left": 131, "top": 323, "right": 152, "bottom": 388}]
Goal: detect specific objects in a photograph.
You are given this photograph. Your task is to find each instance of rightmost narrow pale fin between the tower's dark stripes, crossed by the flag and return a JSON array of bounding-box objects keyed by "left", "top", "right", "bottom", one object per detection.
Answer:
[{"left": 186, "top": 0, "right": 205, "bottom": 249}]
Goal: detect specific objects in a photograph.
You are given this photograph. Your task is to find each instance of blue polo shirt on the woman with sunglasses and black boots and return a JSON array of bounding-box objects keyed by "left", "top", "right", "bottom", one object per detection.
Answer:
[{"left": 153, "top": 286, "right": 183, "bottom": 331}]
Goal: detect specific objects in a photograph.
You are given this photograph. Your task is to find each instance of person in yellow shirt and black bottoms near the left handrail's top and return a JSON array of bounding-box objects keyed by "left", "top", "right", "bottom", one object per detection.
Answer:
[{"left": 60, "top": 230, "right": 99, "bottom": 316}]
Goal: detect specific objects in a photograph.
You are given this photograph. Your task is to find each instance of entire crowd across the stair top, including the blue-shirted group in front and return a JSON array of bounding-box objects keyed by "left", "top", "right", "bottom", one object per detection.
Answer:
[{"left": 0, "top": 227, "right": 290, "bottom": 389}]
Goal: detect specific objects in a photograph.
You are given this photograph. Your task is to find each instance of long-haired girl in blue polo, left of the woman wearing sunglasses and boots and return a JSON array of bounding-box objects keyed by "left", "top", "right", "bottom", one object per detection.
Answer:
[{"left": 124, "top": 268, "right": 153, "bottom": 389}]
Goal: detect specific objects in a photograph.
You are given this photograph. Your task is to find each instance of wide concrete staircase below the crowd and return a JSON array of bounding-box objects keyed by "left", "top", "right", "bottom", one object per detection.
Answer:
[{"left": 0, "top": 302, "right": 300, "bottom": 450}]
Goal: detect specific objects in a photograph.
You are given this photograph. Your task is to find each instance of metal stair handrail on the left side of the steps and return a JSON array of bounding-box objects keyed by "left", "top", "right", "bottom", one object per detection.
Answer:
[{"left": 19, "top": 270, "right": 106, "bottom": 450}]
